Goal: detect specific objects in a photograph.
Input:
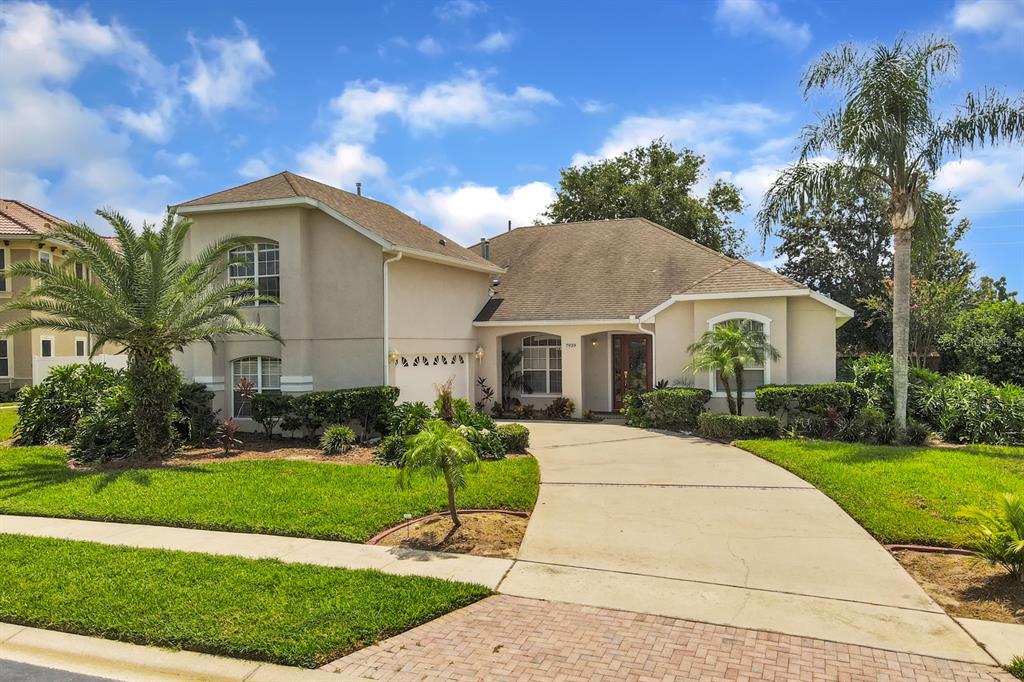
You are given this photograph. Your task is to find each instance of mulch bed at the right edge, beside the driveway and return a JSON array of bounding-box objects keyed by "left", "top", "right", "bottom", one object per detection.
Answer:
[{"left": 893, "top": 551, "right": 1024, "bottom": 625}]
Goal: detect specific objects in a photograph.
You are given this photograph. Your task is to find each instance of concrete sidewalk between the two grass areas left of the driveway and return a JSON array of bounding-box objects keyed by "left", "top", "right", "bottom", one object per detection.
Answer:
[{"left": 0, "top": 515, "right": 512, "bottom": 590}]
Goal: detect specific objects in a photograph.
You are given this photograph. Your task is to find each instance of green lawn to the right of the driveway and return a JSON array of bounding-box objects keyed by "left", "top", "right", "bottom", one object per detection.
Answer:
[{"left": 735, "top": 440, "right": 1024, "bottom": 546}]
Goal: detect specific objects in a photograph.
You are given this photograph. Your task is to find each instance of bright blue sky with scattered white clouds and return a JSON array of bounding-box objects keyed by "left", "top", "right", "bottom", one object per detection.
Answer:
[{"left": 6, "top": 0, "right": 1024, "bottom": 290}]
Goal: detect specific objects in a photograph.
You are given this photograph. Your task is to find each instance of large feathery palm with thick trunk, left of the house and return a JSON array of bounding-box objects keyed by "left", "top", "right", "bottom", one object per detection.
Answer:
[{"left": 0, "top": 210, "right": 281, "bottom": 458}]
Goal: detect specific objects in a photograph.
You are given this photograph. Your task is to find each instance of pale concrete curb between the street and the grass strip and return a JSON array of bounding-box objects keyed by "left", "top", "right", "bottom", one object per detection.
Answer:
[{"left": 0, "top": 623, "right": 369, "bottom": 682}]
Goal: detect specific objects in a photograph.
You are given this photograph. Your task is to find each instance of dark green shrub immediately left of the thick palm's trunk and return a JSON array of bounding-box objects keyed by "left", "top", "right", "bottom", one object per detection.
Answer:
[{"left": 71, "top": 384, "right": 135, "bottom": 462}]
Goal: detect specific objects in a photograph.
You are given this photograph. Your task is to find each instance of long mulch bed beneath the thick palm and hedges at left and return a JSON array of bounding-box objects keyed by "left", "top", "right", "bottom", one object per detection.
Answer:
[{"left": 69, "top": 433, "right": 374, "bottom": 471}]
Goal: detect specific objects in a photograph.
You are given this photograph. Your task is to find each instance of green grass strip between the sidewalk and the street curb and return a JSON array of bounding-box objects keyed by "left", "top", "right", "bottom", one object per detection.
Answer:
[{"left": 0, "top": 535, "right": 489, "bottom": 668}]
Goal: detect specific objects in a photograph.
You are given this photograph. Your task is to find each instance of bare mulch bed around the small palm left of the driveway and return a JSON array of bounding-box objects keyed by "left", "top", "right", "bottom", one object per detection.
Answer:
[{"left": 373, "top": 511, "right": 529, "bottom": 559}]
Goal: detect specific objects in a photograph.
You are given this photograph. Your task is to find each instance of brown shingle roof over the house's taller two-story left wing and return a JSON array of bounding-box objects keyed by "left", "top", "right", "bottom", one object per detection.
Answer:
[{"left": 179, "top": 171, "right": 490, "bottom": 265}]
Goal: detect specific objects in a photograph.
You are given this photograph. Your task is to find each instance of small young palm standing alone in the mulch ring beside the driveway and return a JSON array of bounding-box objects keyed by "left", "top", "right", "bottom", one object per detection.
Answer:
[{"left": 398, "top": 419, "right": 480, "bottom": 527}]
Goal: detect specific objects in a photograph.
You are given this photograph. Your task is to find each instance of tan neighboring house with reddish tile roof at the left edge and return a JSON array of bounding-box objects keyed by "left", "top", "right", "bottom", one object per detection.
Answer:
[{"left": 0, "top": 199, "right": 120, "bottom": 389}]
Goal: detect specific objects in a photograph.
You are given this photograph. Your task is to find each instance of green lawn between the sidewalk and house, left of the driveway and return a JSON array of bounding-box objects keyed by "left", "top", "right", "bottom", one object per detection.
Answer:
[{"left": 0, "top": 447, "right": 539, "bottom": 542}]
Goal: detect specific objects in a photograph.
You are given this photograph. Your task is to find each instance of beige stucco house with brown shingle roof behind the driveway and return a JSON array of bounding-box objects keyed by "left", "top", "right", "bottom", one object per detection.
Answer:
[{"left": 175, "top": 172, "right": 853, "bottom": 419}]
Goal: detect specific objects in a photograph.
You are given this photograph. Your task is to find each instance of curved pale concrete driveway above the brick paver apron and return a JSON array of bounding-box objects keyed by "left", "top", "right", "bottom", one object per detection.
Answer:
[{"left": 499, "top": 423, "right": 992, "bottom": 664}]
